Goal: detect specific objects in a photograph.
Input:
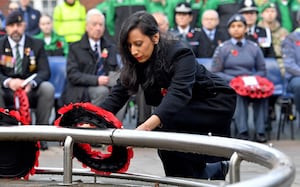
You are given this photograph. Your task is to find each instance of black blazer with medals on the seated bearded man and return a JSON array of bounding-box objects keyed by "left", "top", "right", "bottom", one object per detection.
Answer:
[{"left": 0, "top": 35, "right": 50, "bottom": 85}]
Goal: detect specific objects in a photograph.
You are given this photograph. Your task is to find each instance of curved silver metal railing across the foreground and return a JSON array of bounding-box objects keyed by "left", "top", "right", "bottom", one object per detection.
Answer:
[{"left": 0, "top": 126, "right": 295, "bottom": 187}]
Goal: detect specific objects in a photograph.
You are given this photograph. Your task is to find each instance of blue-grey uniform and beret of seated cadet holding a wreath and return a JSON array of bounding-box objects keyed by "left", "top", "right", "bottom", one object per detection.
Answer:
[{"left": 212, "top": 15, "right": 267, "bottom": 142}]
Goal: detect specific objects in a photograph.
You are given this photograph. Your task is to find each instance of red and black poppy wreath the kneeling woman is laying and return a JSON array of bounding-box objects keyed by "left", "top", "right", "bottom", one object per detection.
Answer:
[{"left": 54, "top": 103, "right": 133, "bottom": 175}]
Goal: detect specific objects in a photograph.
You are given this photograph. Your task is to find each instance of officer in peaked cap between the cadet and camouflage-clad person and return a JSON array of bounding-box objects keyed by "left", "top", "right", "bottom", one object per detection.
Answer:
[{"left": 239, "top": 0, "right": 276, "bottom": 58}]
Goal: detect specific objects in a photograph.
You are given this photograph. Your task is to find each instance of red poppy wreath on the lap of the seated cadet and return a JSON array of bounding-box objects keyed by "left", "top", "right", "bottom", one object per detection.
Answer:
[{"left": 230, "top": 76, "right": 274, "bottom": 99}]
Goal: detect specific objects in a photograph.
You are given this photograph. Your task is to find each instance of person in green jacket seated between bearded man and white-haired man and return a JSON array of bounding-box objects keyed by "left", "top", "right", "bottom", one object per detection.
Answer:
[{"left": 34, "top": 14, "right": 69, "bottom": 57}]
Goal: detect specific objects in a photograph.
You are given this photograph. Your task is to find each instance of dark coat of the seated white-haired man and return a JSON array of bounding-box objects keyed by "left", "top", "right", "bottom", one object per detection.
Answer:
[{"left": 62, "top": 34, "right": 119, "bottom": 104}]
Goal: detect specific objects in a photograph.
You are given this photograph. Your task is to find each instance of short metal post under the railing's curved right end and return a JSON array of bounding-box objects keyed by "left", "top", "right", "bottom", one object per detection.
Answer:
[{"left": 229, "top": 152, "right": 242, "bottom": 184}]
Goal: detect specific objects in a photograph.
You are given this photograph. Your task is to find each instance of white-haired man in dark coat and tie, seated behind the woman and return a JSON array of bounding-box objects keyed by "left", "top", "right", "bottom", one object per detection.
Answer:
[{"left": 62, "top": 9, "right": 119, "bottom": 105}]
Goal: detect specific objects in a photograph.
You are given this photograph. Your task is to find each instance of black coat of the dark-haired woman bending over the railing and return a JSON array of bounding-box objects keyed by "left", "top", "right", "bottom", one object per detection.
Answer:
[{"left": 101, "top": 39, "right": 236, "bottom": 135}]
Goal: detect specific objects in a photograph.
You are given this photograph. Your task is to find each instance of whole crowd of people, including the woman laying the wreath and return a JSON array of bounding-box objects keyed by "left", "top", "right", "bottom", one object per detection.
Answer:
[{"left": 0, "top": 0, "right": 300, "bottom": 179}]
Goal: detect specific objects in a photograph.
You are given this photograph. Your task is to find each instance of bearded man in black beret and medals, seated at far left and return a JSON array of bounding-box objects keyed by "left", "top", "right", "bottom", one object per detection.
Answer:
[{"left": 0, "top": 11, "right": 54, "bottom": 149}]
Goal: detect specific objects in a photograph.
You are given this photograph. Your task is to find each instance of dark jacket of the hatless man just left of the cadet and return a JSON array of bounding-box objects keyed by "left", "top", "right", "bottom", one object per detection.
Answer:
[{"left": 195, "top": 29, "right": 229, "bottom": 58}]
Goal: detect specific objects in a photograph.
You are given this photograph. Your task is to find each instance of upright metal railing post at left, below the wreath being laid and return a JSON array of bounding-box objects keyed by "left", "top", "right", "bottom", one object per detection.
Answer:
[{"left": 63, "top": 136, "right": 74, "bottom": 185}]
